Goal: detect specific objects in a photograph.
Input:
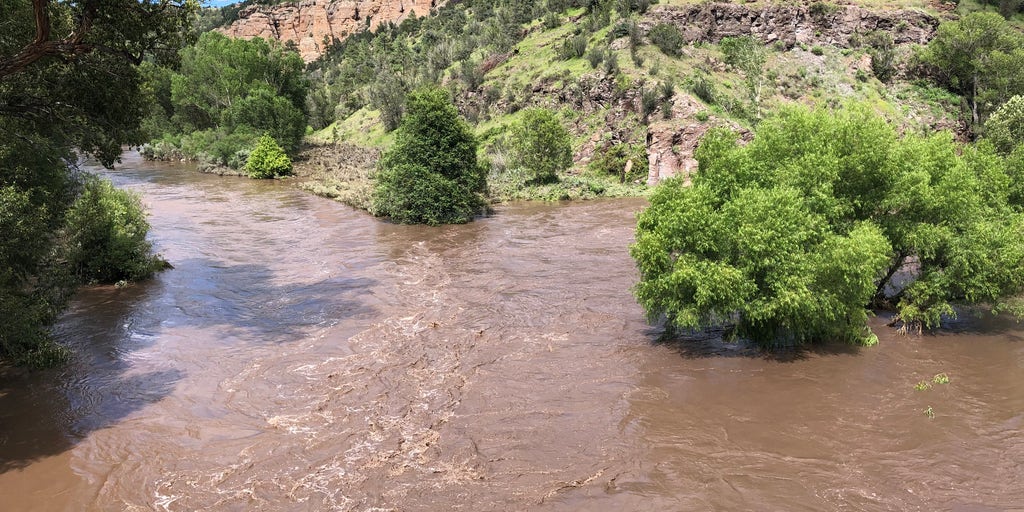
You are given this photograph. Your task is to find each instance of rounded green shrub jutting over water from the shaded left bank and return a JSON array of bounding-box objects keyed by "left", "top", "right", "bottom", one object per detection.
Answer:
[{"left": 66, "top": 177, "right": 166, "bottom": 284}]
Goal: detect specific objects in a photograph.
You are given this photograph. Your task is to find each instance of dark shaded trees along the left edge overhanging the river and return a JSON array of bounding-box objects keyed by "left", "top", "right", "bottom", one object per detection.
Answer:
[{"left": 0, "top": 0, "right": 191, "bottom": 365}]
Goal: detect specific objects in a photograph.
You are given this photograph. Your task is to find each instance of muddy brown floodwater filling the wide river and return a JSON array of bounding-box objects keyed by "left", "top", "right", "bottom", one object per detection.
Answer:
[{"left": 0, "top": 154, "right": 1024, "bottom": 511}]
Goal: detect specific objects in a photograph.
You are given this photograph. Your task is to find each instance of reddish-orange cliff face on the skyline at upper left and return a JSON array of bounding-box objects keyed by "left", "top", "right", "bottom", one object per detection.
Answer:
[{"left": 220, "top": 0, "right": 446, "bottom": 62}]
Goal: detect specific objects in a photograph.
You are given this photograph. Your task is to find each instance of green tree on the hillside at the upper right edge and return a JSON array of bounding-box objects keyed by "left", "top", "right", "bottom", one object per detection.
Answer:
[{"left": 921, "top": 12, "right": 1024, "bottom": 126}]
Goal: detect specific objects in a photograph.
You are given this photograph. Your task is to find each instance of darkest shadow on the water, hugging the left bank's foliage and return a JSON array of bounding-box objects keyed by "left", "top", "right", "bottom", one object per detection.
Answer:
[{"left": 0, "top": 283, "right": 175, "bottom": 474}]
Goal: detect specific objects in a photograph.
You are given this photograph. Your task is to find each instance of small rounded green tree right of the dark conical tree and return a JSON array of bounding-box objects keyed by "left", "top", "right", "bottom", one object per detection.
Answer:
[{"left": 510, "top": 109, "right": 572, "bottom": 183}]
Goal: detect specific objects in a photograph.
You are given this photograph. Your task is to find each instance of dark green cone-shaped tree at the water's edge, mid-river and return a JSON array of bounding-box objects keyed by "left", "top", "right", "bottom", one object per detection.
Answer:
[{"left": 373, "top": 87, "right": 486, "bottom": 225}]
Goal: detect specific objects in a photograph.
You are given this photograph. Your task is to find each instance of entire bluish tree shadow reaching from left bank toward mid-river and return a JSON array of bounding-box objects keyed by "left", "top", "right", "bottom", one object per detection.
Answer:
[{"left": 0, "top": 259, "right": 375, "bottom": 474}]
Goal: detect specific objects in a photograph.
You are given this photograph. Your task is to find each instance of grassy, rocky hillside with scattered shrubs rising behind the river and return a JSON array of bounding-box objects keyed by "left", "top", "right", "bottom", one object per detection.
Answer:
[{"left": 299, "top": 0, "right": 1011, "bottom": 207}]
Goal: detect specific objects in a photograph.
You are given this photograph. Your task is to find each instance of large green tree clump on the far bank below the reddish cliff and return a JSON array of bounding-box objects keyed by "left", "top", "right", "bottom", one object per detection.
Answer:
[{"left": 144, "top": 32, "right": 308, "bottom": 168}]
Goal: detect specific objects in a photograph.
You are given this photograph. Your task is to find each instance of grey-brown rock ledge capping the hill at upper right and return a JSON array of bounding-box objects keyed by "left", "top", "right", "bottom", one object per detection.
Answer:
[{"left": 643, "top": 3, "right": 939, "bottom": 47}]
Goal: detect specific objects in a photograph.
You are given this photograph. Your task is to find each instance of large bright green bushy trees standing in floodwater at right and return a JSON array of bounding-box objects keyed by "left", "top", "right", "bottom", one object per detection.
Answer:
[{"left": 631, "top": 103, "right": 1024, "bottom": 343}]
